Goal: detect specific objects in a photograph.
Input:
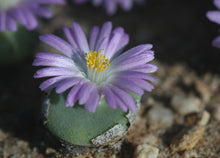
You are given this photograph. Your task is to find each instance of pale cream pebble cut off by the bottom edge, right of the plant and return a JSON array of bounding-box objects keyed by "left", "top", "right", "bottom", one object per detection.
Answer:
[{"left": 134, "top": 144, "right": 159, "bottom": 158}]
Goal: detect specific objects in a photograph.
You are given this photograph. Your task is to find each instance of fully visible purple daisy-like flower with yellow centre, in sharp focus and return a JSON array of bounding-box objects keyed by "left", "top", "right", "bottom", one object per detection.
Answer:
[{"left": 33, "top": 22, "right": 157, "bottom": 112}]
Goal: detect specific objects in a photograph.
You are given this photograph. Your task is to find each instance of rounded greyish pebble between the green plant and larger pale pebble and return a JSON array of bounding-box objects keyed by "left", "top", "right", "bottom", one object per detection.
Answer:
[{"left": 147, "top": 106, "right": 174, "bottom": 128}]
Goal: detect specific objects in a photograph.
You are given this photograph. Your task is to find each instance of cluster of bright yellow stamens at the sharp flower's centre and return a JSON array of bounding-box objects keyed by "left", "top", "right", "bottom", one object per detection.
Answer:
[{"left": 85, "top": 50, "right": 110, "bottom": 72}]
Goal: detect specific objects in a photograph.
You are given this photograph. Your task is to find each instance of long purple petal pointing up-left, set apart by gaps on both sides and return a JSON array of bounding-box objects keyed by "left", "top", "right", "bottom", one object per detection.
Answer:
[{"left": 39, "top": 34, "right": 72, "bottom": 57}]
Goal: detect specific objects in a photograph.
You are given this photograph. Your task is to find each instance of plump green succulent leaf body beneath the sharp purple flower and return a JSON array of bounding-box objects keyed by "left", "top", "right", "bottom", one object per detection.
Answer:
[{"left": 46, "top": 92, "right": 140, "bottom": 145}]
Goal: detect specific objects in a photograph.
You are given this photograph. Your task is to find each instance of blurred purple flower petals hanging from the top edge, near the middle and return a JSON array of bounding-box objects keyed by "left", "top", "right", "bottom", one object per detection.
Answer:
[{"left": 74, "top": 0, "right": 145, "bottom": 15}]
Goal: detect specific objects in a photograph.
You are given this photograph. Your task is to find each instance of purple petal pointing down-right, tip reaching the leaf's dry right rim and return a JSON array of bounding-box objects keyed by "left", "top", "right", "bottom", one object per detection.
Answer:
[{"left": 111, "top": 86, "right": 136, "bottom": 112}]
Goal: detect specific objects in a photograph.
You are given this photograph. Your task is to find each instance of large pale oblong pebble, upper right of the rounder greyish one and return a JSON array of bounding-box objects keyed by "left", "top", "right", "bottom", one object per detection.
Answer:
[{"left": 171, "top": 95, "right": 203, "bottom": 115}]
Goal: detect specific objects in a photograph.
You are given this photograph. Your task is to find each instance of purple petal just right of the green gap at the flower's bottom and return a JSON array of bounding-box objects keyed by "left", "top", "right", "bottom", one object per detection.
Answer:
[{"left": 101, "top": 87, "right": 117, "bottom": 109}]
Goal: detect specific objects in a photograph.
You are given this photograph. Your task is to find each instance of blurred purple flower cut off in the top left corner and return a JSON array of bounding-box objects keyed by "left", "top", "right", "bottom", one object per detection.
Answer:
[{"left": 0, "top": 0, "right": 65, "bottom": 32}]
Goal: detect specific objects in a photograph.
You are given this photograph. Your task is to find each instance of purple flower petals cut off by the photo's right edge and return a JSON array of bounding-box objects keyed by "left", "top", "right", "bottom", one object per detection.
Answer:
[{"left": 206, "top": 0, "right": 220, "bottom": 48}]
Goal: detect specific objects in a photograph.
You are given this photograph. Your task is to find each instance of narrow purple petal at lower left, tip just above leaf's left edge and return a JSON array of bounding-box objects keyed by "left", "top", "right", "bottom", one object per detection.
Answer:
[{"left": 39, "top": 76, "right": 67, "bottom": 91}]
